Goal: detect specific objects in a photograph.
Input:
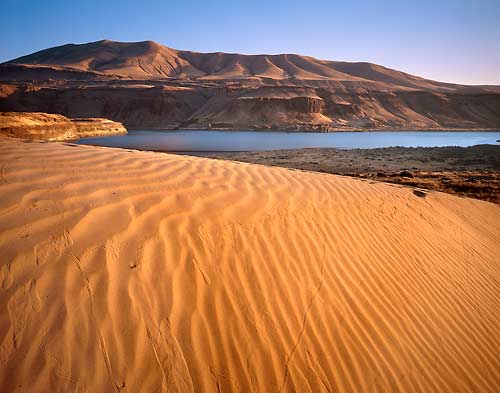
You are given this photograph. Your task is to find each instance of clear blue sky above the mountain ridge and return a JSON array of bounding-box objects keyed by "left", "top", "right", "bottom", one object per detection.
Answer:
[{"left": 0, "top": 0, "right": 500, "bottom": 85}]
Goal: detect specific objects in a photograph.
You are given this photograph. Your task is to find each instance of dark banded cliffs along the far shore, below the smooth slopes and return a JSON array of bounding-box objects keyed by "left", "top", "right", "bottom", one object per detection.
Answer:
[{"left": 0, "top": 85, "right": 500, "bottom": 130}]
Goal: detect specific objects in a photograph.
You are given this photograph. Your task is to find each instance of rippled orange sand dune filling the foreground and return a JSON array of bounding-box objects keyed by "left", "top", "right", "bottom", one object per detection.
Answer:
[{"left": 0, "top": 138, "right": 500, "bottom": 392}]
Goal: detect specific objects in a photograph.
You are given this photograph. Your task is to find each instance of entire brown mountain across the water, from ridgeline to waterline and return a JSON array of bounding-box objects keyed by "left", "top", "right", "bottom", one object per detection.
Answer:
[{"left": 0, "top": 40, "right": 500, "bottom": 130}]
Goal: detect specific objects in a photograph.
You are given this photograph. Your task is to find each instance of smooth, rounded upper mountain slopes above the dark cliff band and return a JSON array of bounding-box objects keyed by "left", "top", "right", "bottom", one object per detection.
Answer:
[{"left": 4, "top": 40, "right": 460, "bottom": 90}]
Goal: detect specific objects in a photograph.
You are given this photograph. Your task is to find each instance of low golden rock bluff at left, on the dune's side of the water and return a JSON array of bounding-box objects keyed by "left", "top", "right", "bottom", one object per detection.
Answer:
[{"left": 0, "top": 112, "right": 127, "bottom": 141}]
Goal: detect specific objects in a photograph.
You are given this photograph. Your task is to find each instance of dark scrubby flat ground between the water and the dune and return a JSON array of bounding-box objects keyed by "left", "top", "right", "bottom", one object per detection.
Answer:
[{"left": 191, "top": 144, "right": 500, "bottom": 204}]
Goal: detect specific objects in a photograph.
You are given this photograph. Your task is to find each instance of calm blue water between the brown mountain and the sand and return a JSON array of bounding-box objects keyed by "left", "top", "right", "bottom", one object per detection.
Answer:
[{"left": 76, "top": 130, "right": 500, "bottom": 152}]
